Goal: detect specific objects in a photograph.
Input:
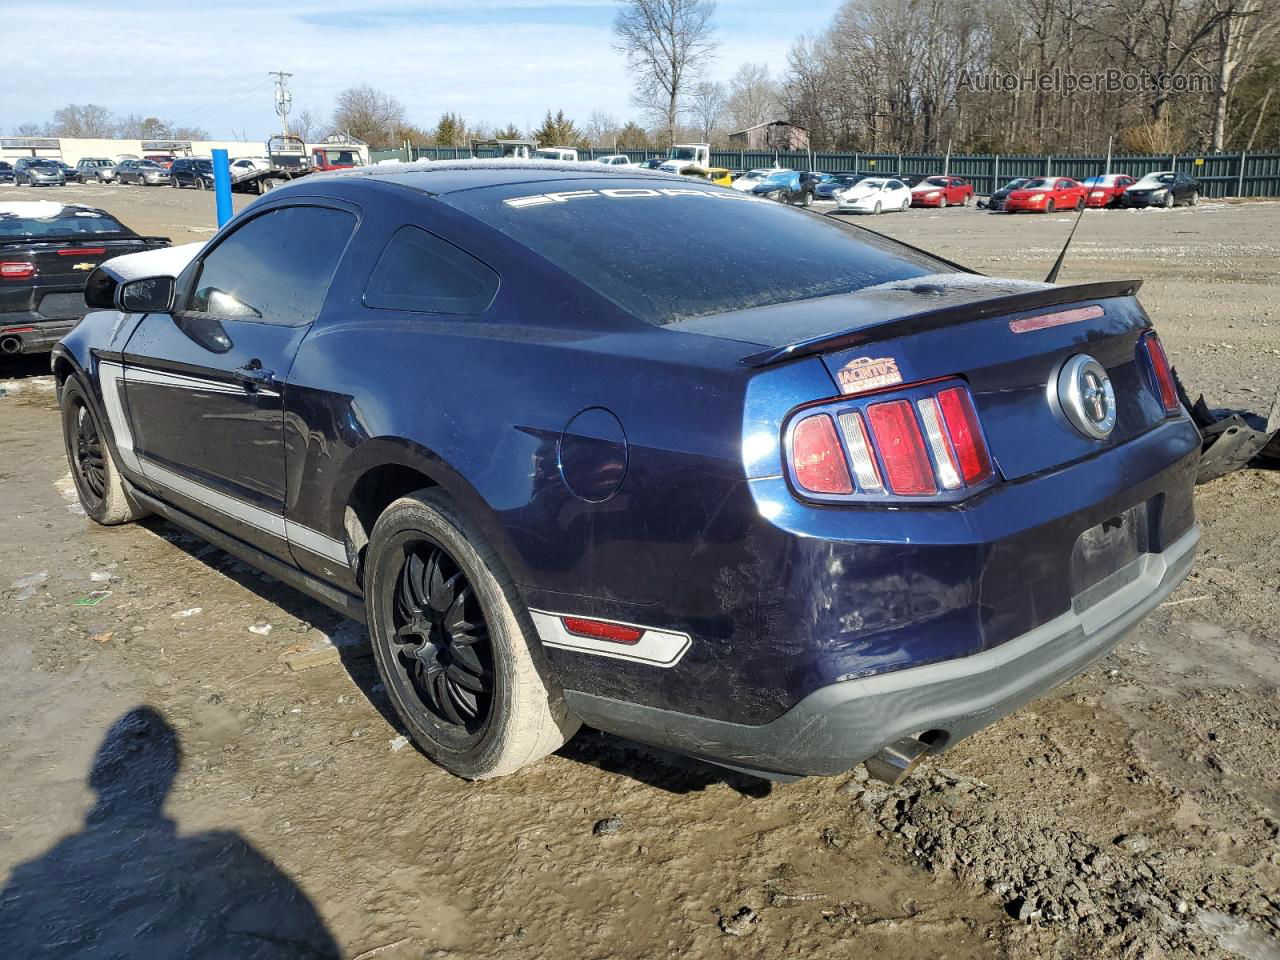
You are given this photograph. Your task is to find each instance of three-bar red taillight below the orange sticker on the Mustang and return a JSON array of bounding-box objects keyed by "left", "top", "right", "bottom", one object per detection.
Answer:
[{"left": 786, "top": 380, "right": 996, "bottom": 500}]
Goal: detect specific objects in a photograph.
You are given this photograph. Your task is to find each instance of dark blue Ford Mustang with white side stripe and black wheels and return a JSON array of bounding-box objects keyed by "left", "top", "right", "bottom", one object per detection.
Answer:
[{"left": 54, "top": 163, "right": 1199, "bottom": 780}]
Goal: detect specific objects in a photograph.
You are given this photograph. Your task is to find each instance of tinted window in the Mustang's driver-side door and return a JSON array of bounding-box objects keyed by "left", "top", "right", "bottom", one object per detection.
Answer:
[{"left": 187, "top": 206, "right": 356, "bottom": 325}]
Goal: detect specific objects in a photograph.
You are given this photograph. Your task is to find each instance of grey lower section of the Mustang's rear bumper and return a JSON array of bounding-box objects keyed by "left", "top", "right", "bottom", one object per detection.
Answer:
[{"left": 564, "top": 527, "right": 1199, "bottom": 776}]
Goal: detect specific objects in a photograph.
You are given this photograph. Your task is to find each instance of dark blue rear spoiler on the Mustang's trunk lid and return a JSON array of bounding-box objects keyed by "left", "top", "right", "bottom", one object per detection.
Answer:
[{"left": 742, "top": 280, "right": 1142, "bottom": 367}]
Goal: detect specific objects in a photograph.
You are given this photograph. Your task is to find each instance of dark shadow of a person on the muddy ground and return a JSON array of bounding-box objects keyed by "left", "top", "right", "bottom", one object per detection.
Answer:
[{"left": 0, "top": 707, "right": 339, "bottom": 960}]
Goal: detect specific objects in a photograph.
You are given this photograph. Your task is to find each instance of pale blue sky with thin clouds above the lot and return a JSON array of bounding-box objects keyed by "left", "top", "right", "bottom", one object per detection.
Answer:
[{"left": 0, "top": 0, "right": 838, "bottom": 140}]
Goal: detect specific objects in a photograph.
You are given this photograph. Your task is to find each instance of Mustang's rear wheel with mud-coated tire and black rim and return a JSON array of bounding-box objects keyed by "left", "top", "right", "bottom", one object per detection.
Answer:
[{"left": 365, "top": 489, "right": 579, "bottom": 780}]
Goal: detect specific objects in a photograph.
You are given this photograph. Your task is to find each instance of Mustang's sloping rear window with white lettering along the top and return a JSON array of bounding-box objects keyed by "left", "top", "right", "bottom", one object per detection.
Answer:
[{"left": 439, "top": 177, "right": 956, "bottom": 324}]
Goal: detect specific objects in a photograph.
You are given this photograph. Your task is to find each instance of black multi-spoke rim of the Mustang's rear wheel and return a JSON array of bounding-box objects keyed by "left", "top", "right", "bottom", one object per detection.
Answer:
[{"left": 393, "top": 538, "right": 494, "bottom": 736}]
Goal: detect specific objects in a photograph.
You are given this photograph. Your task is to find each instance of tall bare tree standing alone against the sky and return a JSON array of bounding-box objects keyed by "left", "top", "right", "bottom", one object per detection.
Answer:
[{"left": 613, "top": 0, "right": 716, "bottom": 143}]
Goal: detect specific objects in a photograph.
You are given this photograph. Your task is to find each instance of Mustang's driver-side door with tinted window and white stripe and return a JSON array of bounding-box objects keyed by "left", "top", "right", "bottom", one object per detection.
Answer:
[{"left": 123, "top": 198, "right": 357, "bottom": 559}]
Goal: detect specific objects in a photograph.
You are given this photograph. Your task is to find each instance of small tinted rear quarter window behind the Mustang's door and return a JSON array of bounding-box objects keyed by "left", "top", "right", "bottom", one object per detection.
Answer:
[{"left": 365, "top": 225, "right": 498, "bottom": 314}]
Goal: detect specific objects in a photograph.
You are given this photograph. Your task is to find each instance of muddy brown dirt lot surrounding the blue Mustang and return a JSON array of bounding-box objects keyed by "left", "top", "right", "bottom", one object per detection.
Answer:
[{"left": 0, "top": 187, "right": 1280, "bottom": 960}]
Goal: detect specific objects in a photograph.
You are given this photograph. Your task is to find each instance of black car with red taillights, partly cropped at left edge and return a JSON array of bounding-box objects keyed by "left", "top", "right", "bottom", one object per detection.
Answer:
[{"left": 0, "top": 200, "right": 169, "bottom": 355}]
